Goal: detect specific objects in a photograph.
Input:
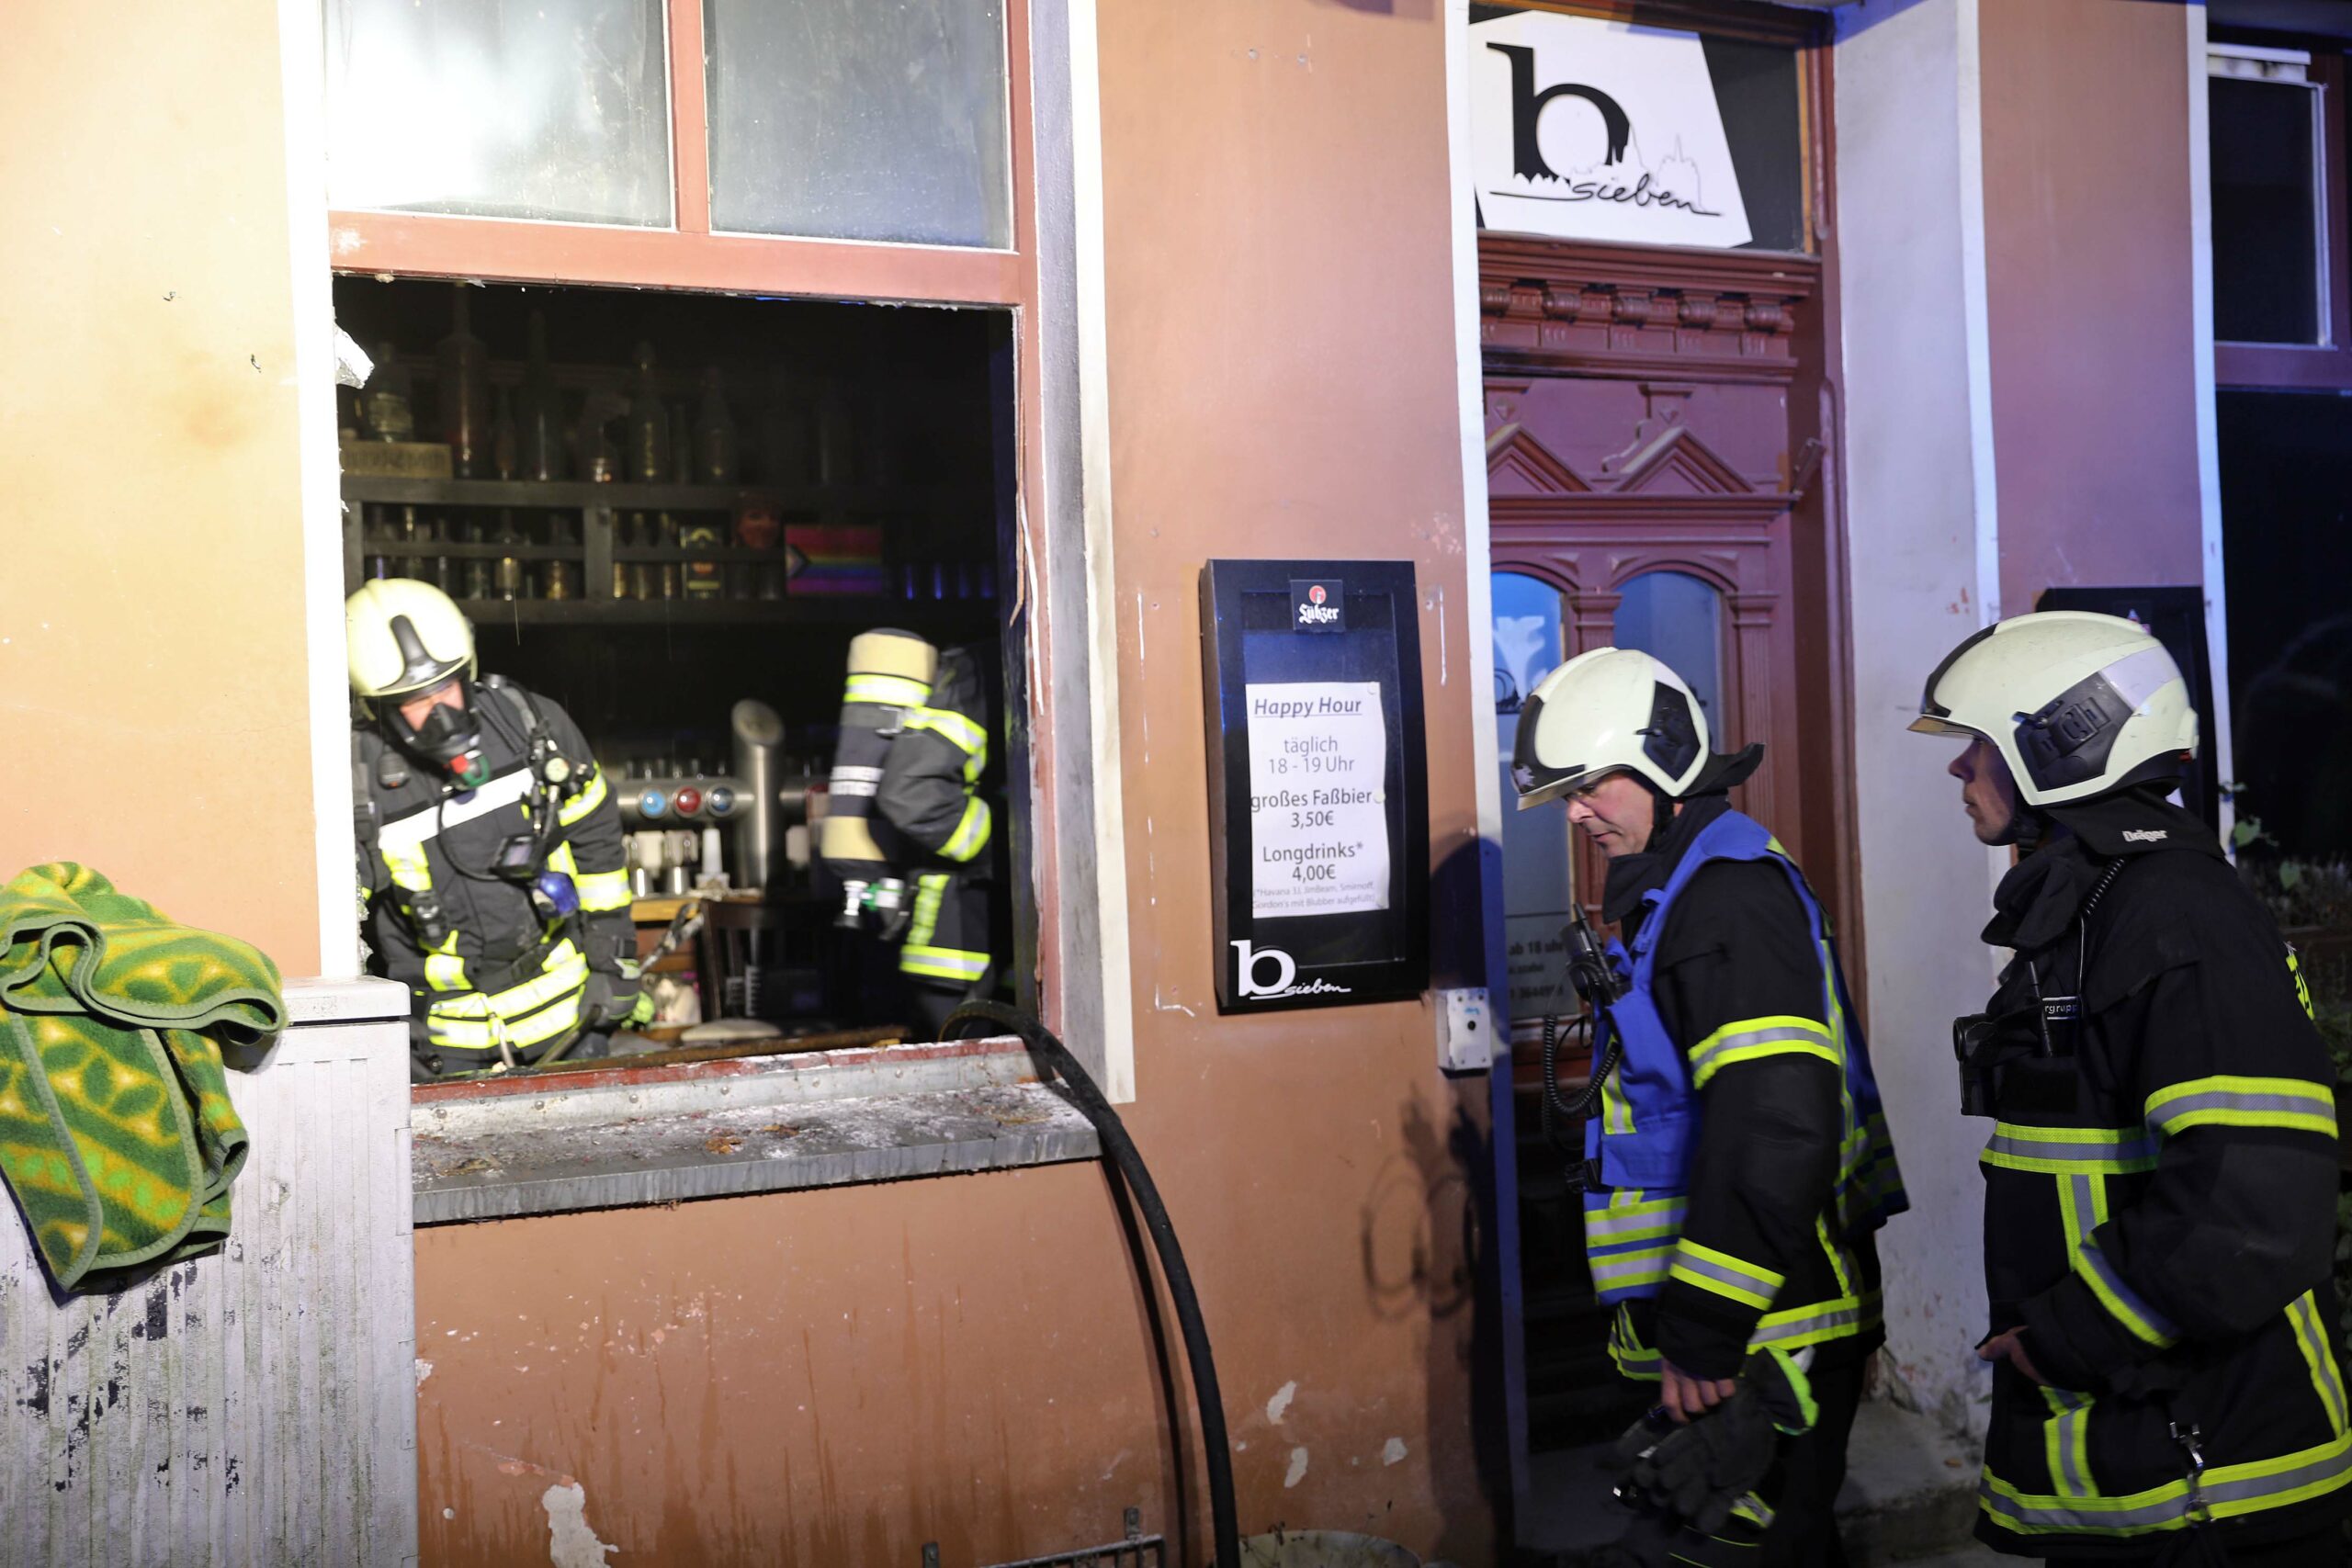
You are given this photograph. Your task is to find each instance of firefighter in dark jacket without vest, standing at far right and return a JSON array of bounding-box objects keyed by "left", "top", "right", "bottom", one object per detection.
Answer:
[{"left": 1912, "top": 611, "right": 2352, "bottom": 1565}]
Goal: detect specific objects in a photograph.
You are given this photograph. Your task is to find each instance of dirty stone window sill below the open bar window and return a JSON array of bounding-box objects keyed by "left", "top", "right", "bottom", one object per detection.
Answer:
[{"left": 412, "top": 1039, "right": 1101, "bottom": 1224}]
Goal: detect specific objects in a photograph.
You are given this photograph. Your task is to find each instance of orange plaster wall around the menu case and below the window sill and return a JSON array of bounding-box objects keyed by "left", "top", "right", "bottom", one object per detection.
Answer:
[{"left": 416, "top": 0, "right": 1503, "bottom": 1568}]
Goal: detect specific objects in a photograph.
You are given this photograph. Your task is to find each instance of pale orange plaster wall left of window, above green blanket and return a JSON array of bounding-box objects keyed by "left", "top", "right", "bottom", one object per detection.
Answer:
[{"left": 0, "top": 0, "right": 320, "bottom": 976}]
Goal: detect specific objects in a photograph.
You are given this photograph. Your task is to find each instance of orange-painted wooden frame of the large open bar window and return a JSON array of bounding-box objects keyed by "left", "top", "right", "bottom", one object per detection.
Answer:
[{"left": 327, "top": 0, "right": 1086, "bottom": 1053}]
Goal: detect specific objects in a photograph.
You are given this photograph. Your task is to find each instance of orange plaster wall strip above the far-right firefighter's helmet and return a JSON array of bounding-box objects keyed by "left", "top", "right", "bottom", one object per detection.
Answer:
[{"left": 1981, "top": 0, "right": 2204, "bottom": 614}]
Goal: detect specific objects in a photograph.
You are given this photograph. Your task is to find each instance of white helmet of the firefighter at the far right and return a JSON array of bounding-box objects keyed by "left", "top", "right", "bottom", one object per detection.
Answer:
[{"left": 1912, "top": 609, "right": 2197, "bottom": 807}]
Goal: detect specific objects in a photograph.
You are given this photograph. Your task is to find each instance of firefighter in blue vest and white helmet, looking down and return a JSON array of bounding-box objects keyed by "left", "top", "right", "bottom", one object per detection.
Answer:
[{"left": 1512, "top": 649, "right": 1905, "bottom": 1565}]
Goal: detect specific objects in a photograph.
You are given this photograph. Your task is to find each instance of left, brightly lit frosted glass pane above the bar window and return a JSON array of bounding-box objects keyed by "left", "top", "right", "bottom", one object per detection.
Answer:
[{"left": 327, "top": 0, "right": 671, "bottom": 226}]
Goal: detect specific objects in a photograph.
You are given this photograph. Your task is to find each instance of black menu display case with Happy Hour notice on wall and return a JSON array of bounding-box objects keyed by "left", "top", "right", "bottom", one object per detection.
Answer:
[{"left": 1200, "top": 562, "right": 1430, "bottom": 1013}]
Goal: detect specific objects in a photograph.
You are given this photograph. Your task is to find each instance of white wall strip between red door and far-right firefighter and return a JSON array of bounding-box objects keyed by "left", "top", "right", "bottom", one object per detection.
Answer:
[{"left": 1835, "top": 0, "right": 1999, "bottom": 1427}]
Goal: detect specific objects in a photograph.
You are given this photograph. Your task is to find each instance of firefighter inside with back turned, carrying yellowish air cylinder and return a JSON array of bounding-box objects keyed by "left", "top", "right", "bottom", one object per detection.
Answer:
[{"left": 816, "top": 627, "right": 997, "bottom": 1039}]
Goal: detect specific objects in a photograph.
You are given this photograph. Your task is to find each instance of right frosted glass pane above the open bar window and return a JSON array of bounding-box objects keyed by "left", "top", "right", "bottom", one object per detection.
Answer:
[{"left": 703, "top": 0, "right": 1013, "bottom": 249}]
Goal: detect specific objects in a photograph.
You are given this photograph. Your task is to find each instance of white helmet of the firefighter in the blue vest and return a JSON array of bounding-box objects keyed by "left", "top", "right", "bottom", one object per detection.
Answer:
[{"left": 1510, "top": 649, "right": 1708, "bottom": 811}]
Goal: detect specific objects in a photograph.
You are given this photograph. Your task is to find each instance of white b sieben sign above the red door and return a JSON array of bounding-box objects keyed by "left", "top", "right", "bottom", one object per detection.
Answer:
[{"left": 1470, "top": 12, "right": 1752, "bottom": 249}]
